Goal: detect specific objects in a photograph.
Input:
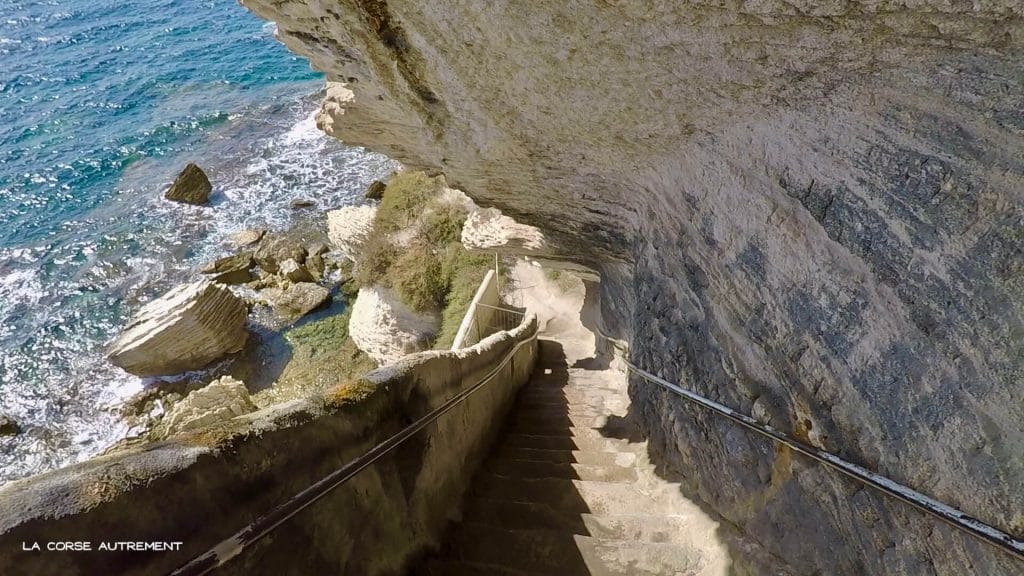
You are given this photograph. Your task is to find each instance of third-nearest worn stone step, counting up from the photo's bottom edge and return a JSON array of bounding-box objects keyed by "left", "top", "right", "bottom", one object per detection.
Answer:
[{"left": 470, "top": 471, "right": 674, "bottom": 515}]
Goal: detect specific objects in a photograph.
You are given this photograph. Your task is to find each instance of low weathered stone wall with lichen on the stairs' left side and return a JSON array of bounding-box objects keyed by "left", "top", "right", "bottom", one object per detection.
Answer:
[{"left": 0, "top": 316, "right": 537, "bottom": 576}]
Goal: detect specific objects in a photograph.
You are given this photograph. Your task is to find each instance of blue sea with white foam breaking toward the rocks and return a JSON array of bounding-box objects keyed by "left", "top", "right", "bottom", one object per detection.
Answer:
[{"left": 0, "top": 0, "right": 395, "bottom": 483}]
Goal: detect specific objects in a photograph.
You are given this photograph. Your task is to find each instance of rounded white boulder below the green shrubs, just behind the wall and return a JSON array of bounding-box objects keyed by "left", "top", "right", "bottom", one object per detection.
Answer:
[{"left": 348, "top": 286, "right": 439, "bottom": 364}]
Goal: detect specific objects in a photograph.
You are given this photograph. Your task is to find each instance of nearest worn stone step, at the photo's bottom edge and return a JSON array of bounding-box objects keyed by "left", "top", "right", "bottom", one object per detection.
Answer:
[{"left": 449, "top": 525, "right": 705, "bottom": 576}]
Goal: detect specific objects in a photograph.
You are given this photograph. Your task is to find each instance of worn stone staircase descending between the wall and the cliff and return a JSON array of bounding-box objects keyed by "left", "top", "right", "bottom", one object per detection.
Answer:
[{"left": 414, "top": 340, "right": 729, "bottom": 576}]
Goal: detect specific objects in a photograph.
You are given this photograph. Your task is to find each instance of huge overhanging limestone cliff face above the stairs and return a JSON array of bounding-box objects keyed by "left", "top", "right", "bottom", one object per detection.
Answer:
[{"left": 243, "top": 0, "right": 1024, "bottom": 575}]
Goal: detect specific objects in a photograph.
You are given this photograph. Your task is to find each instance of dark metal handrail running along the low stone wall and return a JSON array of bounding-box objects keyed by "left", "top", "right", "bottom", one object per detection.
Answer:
[{"left": 171, "top": 317, "right": 540, "bottom": 576}]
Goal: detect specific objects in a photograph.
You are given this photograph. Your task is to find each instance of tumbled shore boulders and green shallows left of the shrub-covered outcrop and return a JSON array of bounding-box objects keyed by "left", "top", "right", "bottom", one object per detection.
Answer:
[{"left": 108, "top": 164, "right": 383, "bottom": 444}]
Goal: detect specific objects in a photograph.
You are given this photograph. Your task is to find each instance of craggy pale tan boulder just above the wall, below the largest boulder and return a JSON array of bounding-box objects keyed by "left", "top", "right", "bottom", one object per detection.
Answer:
[{"left": 163, "top": 376, "right": 256, "bottom": 436}]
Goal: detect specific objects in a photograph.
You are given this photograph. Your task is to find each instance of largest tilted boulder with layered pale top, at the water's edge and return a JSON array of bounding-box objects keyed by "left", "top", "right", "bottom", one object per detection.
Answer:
[{"left": 106, "top": 281, "right": 248, "bottom": 376}]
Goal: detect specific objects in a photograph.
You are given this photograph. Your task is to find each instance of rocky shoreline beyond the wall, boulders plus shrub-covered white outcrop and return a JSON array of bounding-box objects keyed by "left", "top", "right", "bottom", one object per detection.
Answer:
[{"left": 108, "top": 165, "right": 493, "bottom": 452}]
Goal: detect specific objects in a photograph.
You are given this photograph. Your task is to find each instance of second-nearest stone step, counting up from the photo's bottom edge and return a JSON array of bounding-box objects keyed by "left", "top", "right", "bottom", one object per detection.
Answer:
[{"left": 463, "top": 497, "right": 691, "bottom": 543}]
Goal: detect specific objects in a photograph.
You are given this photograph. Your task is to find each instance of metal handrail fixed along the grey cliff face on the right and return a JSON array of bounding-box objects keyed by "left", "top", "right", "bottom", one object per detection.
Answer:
[{"left": 614, "top": 350, "right": 1024, "bottom": 560}]
